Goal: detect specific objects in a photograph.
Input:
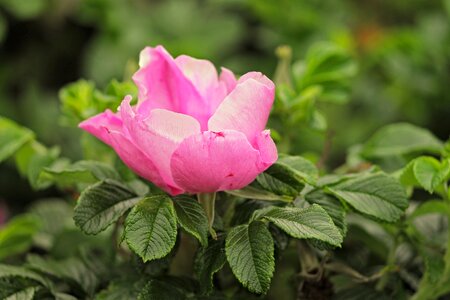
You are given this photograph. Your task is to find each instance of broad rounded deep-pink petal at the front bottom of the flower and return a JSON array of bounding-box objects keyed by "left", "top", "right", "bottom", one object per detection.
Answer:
[{"left": 171, "top": 130, "right": 273, "bottom": 193}]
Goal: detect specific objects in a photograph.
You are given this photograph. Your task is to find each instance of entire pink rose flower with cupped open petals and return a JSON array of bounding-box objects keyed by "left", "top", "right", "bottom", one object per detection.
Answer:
[{"left": 79, "top": 46, "right": 277, "bottom": 195}]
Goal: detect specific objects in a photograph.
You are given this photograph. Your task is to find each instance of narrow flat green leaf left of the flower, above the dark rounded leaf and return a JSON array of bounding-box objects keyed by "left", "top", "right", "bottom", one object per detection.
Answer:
[{"left": 41, "top": 160, "right": 120, "bottom": 186}]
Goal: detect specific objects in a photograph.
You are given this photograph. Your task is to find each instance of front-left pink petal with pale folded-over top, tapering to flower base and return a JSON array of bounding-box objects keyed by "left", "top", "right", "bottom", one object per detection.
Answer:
[{"left": 120, "top": 100, "right": 200, "bottom": 192}]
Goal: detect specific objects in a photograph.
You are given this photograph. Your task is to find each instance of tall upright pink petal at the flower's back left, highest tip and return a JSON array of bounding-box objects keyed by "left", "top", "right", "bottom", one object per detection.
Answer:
[{"left": 133, "top": 46, "right": 210, "bottom": 127}]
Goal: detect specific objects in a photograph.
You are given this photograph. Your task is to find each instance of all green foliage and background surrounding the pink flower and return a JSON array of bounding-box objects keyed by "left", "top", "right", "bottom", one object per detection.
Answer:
[{"left": 0, "top": 0, "right": 450, "bottom": 299}]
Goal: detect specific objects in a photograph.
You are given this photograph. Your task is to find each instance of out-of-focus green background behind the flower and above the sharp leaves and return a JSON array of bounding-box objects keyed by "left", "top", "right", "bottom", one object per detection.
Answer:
[{"left": 0, "top": 0, "right": 450, "bottom": 216}]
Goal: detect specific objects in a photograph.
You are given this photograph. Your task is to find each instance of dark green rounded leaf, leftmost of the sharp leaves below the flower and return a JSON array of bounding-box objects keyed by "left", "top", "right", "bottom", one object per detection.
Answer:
[{"left": 73, "top": 179, "right": 141, "bottom": 234}]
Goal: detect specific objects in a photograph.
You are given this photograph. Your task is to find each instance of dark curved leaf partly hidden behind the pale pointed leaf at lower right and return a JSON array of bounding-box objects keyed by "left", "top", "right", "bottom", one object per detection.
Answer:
[{"left": 305, "top": 190, "right": 347, "bottom": 237}]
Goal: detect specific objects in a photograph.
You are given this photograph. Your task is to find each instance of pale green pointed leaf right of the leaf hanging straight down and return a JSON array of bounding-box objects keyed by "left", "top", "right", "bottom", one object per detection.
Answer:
[{"left": 258, "top": 204, "right": 342, "bottom": 247}]
